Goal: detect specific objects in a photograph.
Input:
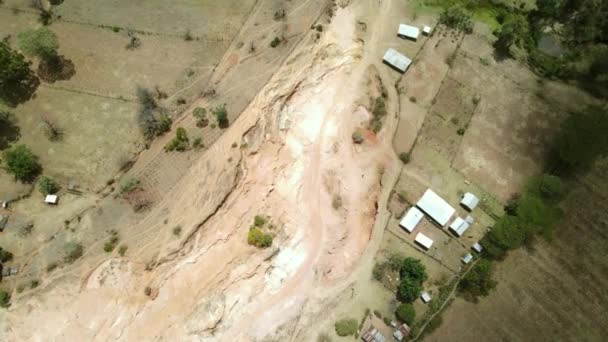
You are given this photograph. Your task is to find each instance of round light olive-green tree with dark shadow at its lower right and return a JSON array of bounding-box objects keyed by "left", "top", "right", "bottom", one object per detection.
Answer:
[{"left": 17, "top": 27, "right": 59, "bottom": 61}]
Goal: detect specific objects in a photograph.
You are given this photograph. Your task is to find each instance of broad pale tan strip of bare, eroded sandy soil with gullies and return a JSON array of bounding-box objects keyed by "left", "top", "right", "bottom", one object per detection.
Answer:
[{"left": 1, "top": 6, "right": 404, "bottom": 341}]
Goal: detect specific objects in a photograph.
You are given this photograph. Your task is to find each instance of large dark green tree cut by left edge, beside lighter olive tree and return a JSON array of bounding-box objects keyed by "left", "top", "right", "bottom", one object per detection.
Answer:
[{"left": 0, "top": 41, "right": 39, "bottom": 105}]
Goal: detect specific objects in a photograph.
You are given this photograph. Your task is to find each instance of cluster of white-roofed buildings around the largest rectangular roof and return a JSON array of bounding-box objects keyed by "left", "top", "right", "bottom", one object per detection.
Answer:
[{"left": 399, "top": 189, "right": 482, "bottom": 264}]
